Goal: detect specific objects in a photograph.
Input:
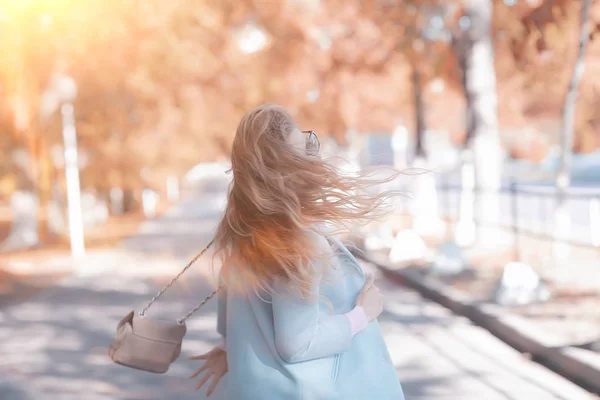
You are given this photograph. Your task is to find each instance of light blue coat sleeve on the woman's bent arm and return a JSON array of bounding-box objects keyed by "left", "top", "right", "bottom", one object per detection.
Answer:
[{"left": 272, "top": 264, "right": 353, "bottom": 363}]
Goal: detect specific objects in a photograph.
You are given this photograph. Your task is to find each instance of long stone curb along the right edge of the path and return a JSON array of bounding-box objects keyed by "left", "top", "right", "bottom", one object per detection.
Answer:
[{"left": 353, "top": 252, "right": 600, "bottom": 395}]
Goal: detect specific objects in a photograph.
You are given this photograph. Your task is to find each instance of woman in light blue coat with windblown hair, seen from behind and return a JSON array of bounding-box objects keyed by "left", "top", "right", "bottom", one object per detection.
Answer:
[{"left": 191, "top": 105, "right": 403, "bottom": 400}]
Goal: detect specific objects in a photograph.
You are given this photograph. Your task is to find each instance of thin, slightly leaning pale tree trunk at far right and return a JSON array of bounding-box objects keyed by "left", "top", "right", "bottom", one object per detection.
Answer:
[{"left": 554, "top": 0, "right": 591, "bottom": 261}]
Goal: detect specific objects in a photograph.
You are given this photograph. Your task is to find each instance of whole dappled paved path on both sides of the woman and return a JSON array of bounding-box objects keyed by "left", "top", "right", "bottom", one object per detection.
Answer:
[{"left": 0, "top": 179, "right": 593, "bottom": 400}]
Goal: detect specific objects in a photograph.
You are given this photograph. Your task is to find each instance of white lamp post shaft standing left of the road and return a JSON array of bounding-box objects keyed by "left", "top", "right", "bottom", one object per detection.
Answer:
[{"left": 61, "top": 103, "right": 85, "bottom": 259}]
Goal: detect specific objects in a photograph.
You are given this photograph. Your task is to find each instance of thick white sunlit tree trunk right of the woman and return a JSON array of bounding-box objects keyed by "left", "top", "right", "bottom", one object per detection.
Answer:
[{"left": 454, "top": 0, "right": 502, "bottom": 247}]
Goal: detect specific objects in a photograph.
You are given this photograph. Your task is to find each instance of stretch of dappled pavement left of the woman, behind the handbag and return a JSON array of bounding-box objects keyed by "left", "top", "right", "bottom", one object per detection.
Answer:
[{"left": 0, "top": 200, "right": 223, "bottom": 400}]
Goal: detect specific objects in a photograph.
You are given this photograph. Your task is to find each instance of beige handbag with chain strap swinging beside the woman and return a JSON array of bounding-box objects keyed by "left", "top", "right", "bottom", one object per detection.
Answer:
[{"left": 108, "top": 241, "right": 223, "bottom": 374}]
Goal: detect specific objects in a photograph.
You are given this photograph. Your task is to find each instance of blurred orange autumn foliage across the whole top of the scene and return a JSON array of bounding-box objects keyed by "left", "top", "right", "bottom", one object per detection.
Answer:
[{"left": 0, "top": 0, "right": 600, "bottom": 197}]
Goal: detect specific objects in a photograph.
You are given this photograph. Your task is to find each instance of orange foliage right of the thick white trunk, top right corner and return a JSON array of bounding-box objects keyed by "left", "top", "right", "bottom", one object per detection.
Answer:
[{"left": 494, "top": 0, "right": 600, "bottom": 152}]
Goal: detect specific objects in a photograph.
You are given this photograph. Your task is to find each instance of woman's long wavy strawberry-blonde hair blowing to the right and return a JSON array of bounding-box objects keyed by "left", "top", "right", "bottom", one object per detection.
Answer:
[{"left": 214, "top": 105, "right": 398, "bottom": 294}]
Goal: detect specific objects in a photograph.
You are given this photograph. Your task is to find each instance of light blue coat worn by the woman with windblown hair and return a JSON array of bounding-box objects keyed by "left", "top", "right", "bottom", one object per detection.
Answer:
[{"left": 211, "top": 235, "right": 404, "bottom": 400}]
